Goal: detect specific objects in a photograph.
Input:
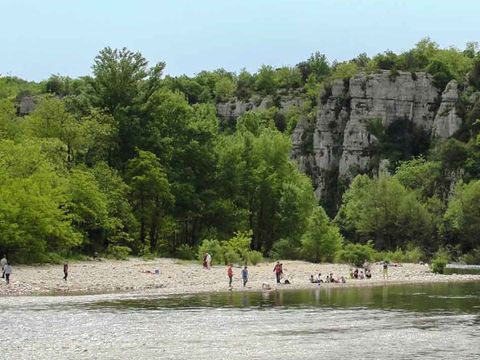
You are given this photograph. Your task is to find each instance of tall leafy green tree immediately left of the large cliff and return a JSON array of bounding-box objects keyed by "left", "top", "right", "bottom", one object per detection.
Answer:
[{"left": 217, "top": 113, "right": 314, "bottom": 253}]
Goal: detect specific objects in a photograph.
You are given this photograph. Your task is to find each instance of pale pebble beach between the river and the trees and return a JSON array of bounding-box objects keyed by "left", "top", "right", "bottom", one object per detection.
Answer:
[{"left": 0, "top": 258, "right": 480, "bottom": 297}]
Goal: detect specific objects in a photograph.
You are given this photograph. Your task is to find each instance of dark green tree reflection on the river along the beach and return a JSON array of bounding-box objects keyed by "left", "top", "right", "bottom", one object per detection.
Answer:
[{"left": 85, "top": 282, "right": 480, "bottom": 313}]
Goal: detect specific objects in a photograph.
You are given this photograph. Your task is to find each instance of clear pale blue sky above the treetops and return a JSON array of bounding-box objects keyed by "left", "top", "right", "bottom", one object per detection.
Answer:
[{"left": 0, "top": 0, "right": 480, "bottom": 80}]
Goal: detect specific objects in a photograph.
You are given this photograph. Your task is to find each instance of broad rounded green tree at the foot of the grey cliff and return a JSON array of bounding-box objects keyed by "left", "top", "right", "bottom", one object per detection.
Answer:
[{"left": 336, "top": 175, "right": 434, "bottom": 250}]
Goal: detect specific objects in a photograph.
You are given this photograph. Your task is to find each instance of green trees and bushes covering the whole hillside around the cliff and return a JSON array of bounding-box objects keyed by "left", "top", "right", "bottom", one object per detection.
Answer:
[{"left": 0, "top": 39, "right": 480, "bottom": 263}]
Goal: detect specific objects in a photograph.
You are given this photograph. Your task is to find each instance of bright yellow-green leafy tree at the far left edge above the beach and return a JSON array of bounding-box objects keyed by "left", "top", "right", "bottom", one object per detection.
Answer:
[{"left": 0, "top": 140, "right": 82, "bottom": 261}]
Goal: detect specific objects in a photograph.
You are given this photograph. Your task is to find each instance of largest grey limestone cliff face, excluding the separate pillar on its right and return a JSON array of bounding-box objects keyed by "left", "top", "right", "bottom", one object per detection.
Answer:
[{"left": 293, "top": 71, "right": 443, "bottom": 202}]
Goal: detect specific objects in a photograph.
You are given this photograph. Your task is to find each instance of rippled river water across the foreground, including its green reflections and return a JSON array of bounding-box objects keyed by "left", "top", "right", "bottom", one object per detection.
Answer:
[{"left": 0, "top": 282, "right": 480, "bottom": 360}]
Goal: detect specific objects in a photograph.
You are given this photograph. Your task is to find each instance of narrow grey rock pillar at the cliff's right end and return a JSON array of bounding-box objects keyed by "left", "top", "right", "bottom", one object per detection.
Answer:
[{"left": 432, "top": 80, "right": 462, "bottom": 139}]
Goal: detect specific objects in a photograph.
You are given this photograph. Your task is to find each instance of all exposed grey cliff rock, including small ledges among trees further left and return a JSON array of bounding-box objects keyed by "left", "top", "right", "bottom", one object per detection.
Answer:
[{"left": 218, "top": 71, "right": 462, "bottom": 211}]
